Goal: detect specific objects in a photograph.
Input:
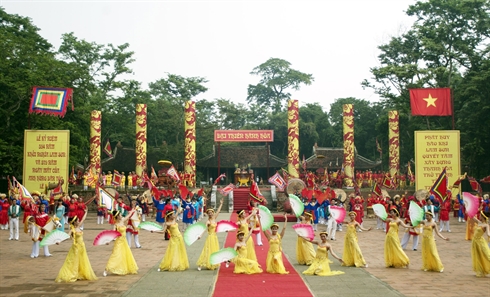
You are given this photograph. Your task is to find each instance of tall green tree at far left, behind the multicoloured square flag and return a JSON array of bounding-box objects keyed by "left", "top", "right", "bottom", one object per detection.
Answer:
[{"left": 0, "top": 7, "right": 69, "bottom": 177}]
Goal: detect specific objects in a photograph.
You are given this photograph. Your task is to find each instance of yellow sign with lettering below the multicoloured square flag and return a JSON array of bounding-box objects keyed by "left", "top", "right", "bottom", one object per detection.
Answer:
[{"left": 22, "top": 130, "right": 70, "bottom": 192}]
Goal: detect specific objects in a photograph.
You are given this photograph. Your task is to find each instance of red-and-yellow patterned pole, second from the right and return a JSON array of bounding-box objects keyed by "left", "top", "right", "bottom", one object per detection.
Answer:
[{"left": 343, "top": 104, "right": 354, "bottom": 187}]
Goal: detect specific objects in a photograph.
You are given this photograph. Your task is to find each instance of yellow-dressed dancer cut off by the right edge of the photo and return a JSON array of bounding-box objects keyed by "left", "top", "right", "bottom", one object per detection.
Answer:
[{"left": 471, "top": 211, "right": 490, "bottom": 277}]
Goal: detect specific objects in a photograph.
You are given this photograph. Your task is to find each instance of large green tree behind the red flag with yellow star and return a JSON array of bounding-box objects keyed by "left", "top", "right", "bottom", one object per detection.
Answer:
[{"left": 363, "top": 0, "right": 490, "bottom": 174}]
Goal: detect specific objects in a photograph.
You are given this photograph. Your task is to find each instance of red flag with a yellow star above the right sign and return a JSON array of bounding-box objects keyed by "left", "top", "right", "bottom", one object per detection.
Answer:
[{"left": 410, "top": 88, "right": 453, "bottom": 116}]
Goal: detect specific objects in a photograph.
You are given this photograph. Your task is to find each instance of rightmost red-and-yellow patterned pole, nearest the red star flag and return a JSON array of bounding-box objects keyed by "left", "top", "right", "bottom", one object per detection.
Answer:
[{"left": 388, "top": 110, "right": 400, "bottom": 177}]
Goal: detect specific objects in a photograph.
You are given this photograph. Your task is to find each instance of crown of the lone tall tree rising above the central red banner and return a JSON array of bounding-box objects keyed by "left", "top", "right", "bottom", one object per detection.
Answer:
[{"left": 247, "top": 58, "right": 314, "bottom": 112}]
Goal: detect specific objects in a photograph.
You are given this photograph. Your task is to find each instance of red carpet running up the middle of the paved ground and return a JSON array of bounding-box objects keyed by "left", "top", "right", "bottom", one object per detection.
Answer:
[{"left": 213, "top": 213, "right": 312, "bottom": 297}]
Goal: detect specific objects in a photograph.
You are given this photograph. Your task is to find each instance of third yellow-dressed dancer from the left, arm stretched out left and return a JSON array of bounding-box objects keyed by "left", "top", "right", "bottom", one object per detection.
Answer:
[{"left": 151, "top": 211, "right": 189, "bottom": 271}]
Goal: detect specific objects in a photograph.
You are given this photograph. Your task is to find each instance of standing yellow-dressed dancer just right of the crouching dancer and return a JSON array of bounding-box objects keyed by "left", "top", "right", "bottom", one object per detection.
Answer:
[{"left": 342, "top": 211, "right": 372, "bottom": 267}]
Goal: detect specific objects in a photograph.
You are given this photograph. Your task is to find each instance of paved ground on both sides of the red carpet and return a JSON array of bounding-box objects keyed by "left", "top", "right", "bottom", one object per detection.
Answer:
[{"left": 0, "top": 213, "right": 490, "bottom": 297}]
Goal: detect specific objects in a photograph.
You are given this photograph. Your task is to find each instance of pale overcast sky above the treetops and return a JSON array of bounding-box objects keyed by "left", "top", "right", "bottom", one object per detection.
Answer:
[{"left": 0, "top": 0, "right": 416, "bottom": 110}]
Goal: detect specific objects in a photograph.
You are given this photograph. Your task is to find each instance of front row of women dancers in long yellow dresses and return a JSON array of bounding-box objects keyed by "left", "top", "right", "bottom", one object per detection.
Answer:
[{"left": 28, "top": 201, "right": 490, "bottom": 282}]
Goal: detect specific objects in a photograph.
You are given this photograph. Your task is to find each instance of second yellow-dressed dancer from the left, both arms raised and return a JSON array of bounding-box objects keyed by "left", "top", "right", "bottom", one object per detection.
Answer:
[{"left": 104, "top": 210, "right": 138, "bottom": 276}]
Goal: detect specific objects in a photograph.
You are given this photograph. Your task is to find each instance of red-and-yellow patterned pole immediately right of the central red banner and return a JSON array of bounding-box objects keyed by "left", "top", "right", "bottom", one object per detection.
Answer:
[{"left": 288, "top": 100, "right": 299, "bottom": 178}]
